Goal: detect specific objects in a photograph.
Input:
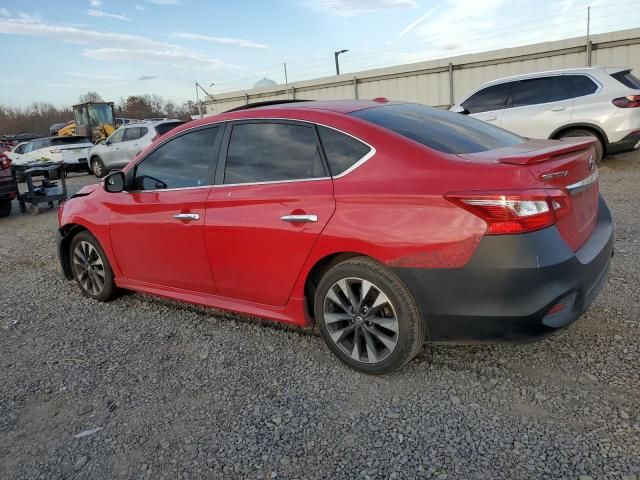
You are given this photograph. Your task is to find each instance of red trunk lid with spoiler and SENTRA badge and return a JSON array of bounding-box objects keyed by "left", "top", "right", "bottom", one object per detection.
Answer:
[{"left": 458, "top": 137, "right": 599, "bottom": 251}]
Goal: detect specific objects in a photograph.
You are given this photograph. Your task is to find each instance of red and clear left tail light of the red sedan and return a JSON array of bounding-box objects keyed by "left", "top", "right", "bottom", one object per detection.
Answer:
[{"left": 445, "top": 189, "right": 571, "bottom": 235}]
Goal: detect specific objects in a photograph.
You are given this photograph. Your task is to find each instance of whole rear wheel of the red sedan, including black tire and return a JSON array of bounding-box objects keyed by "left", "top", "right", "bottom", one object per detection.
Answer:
[{"left": 314, "top": 257, "right": 426, "bottom": 375}]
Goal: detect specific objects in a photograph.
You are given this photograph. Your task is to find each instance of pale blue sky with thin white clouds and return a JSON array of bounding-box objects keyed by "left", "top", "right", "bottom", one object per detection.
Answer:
[{"left": 0, "top": 0, "right": 640, "bottom": 107}]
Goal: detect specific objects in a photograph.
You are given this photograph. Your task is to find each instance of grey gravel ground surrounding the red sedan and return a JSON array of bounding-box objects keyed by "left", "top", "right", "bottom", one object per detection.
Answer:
[{"left": 0, "top": 153, "right": 640, "bottom": 480}]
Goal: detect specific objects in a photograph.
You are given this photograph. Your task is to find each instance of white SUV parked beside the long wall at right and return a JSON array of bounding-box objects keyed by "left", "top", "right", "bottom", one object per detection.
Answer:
[{"left": 451, "top": 67, "right": 640, "bottom": 162}]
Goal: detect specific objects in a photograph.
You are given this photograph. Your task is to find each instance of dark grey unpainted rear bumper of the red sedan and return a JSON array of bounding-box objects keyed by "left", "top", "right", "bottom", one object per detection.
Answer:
[{"left": 394, "top": 197, "right": 613, "bottom": 343}]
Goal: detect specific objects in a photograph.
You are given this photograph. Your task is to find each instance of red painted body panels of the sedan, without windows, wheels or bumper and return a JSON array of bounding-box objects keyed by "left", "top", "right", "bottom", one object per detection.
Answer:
[{"left": 59, "top": 101, "right": 597, "bottom": 325}]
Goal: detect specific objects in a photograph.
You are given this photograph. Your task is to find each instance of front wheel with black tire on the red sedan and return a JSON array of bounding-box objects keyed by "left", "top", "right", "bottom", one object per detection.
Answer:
[{"left": 69, "top": 230, "right": 118, "bottom": 302}]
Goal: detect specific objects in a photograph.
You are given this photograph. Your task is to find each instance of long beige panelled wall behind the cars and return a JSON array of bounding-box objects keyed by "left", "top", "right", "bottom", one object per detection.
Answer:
[{"left": 205, "top": 28, "right": 640, "bottom": 115}]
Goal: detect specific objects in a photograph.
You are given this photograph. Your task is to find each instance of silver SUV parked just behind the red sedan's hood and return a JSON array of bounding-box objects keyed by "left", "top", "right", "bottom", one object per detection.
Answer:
[{"left": 89, "top": 120, "right": 184, "bottom": 178}]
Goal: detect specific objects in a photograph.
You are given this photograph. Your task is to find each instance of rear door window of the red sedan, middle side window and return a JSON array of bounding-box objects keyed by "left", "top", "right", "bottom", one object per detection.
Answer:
[{"left": 224, "top": 122, "right": 326, "bottom": 184}]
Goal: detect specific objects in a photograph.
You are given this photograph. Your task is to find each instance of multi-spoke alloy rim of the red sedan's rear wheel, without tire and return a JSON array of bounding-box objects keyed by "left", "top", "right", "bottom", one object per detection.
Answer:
[{"left": 323, "top": 277, "right": 399, "bottom": 364}]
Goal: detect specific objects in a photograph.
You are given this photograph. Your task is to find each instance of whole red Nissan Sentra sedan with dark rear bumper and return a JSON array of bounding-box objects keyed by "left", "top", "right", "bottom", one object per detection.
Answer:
[{"left": 58, "top": 100, "right": 613, "bottom": 374}]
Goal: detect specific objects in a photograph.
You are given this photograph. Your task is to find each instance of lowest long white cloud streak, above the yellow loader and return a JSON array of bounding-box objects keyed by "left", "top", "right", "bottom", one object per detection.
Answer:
[{"left": 82, "top": 48, "right": 231, "bottom": 70}]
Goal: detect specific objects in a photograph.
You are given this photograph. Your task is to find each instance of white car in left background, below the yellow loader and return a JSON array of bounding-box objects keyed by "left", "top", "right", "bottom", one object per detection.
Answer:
[{"left": 10, "top": 137, "right": 93, "bottom": 182}]
